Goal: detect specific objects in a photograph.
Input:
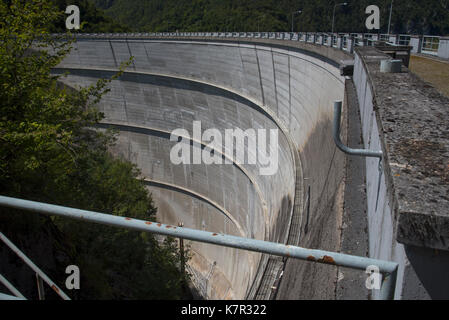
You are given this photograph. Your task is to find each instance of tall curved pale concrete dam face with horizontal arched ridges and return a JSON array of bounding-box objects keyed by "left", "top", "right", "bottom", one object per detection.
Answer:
[{"left": 54, "top": 39, "right": 345, "bottom": 299}]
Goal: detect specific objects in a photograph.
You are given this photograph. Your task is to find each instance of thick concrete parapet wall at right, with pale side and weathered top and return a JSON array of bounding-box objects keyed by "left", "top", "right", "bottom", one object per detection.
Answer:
[{"left": 354, "top": 48, "right": 449, "bottom": 299}]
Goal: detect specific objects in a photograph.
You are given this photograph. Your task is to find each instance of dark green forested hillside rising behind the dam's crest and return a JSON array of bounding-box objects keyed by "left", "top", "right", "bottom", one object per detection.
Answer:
[{"left": 91, "top": 0, "right": 449, "bottom": 35}]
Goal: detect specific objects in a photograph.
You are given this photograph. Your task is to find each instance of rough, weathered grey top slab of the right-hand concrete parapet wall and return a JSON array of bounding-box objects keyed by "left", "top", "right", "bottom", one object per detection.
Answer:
[{"left": 356, "top": 47, "right": 449, "bottom": 250}]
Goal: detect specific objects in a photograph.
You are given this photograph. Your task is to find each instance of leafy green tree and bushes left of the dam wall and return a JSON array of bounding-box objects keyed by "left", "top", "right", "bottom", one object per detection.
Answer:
[{"left": 0, "top": 0, "right": 186, "bottom": 299}]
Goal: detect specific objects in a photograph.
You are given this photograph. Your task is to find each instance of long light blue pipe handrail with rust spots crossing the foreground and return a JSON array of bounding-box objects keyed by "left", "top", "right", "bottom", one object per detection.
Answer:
[{"left": 0, "top": 196, "right": 398, "bottom": 299}]
